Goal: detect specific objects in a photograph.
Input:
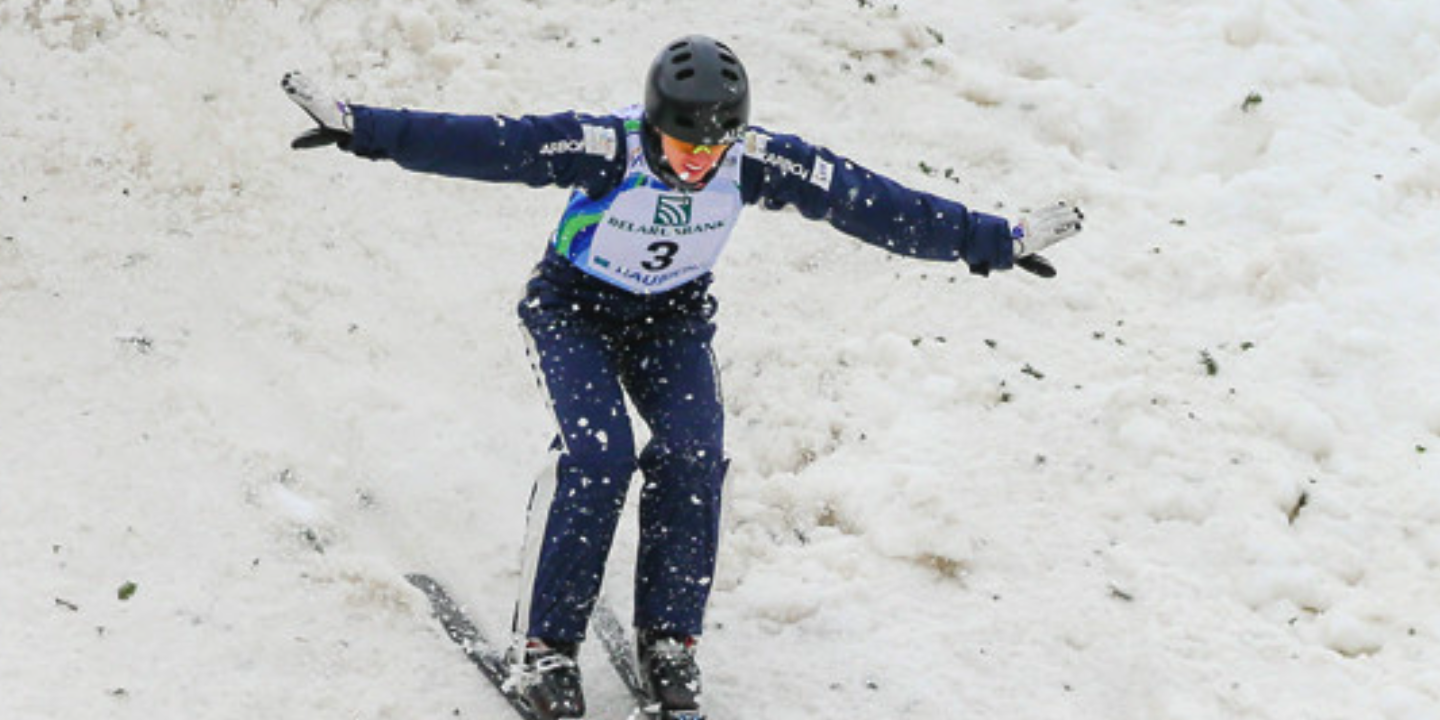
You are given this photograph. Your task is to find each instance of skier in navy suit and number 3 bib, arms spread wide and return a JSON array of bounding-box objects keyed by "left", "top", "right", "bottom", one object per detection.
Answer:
[{"left": 282, "top": 36, "right": 1081, "bottom": 717}]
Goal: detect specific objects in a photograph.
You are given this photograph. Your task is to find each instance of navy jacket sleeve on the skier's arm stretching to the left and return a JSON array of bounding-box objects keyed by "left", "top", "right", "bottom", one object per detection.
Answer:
[{"left": 346, "top": 105, "right": 625, "bottom": 196}]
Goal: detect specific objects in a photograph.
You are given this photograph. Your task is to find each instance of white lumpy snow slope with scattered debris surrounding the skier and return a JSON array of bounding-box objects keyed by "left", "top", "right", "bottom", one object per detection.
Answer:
[{"left": 0, "top": 0, "right": 1440, "bottom": 720}]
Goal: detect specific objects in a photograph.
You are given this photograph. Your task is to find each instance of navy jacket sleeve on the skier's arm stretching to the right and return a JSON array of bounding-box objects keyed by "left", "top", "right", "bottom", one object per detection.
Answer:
[{"left": 740, "top": 128, "right": 1015, "bottom": 275}]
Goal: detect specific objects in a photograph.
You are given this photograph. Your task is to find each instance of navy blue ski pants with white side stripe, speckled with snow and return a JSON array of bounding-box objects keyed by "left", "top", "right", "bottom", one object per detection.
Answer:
[{"left": 516, "top": 253, "right": 726, "bottom": 642}]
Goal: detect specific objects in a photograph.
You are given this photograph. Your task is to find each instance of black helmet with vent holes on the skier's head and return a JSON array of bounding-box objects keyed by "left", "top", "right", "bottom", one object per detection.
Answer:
[{"left": 645, "top": 35, "right": 750, "bottom": 145}]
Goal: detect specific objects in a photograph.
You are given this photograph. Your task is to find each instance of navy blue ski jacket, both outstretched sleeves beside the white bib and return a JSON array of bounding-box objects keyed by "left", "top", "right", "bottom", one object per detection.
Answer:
[{"left": 346, "top": 105, "right": 1014, "bottom": 275}]
